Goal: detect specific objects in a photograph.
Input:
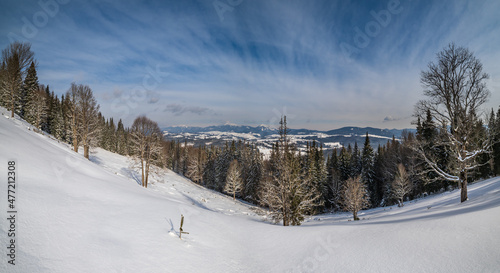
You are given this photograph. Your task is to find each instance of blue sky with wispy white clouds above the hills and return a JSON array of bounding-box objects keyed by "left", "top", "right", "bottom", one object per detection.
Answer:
[{"left": 0, "top": 0, "right": 500, "bottom": 129}]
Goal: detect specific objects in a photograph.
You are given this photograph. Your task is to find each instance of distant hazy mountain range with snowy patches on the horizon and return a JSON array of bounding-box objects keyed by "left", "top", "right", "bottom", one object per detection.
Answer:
[{"left": 162, "top": 125, "right": 415, "bottom": 153}]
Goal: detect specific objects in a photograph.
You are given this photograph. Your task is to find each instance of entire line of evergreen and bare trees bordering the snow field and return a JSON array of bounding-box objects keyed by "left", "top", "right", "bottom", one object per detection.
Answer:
[{"left": 0, "top": 42, "right": 500, "bottom": 225}]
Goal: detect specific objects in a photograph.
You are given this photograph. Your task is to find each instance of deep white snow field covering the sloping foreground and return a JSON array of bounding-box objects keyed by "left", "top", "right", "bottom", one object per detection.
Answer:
[{"left": 0, "top": 108, "right": 500, "bottom": 272}]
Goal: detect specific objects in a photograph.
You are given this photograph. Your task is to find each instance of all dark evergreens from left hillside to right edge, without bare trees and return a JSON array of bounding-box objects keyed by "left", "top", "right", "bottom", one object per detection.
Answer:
[{"left": 4, "top": 61, "right": 500, "bottom": 211}]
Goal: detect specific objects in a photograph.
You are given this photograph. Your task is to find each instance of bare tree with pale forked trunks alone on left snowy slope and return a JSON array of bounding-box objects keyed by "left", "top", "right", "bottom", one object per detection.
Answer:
[{"left": 130, "top": 116, "right": 162, "bottom": 188}]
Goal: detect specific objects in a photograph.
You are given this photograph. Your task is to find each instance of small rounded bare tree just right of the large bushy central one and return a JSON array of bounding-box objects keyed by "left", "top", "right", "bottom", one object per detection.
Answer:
[{"left": 341, "top": 176, "right": 370, "bottom": 221}]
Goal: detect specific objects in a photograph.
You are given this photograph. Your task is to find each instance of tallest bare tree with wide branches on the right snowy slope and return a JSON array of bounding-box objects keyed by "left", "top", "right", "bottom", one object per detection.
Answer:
[{"left": 416, "top": 44, "right": 491, "bottom": 202}]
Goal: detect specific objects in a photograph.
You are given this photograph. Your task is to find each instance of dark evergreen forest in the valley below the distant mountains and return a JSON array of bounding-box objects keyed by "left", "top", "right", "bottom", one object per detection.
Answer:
[{"left": 166, "top": 112, "right": 500, "bottom": 211}]
